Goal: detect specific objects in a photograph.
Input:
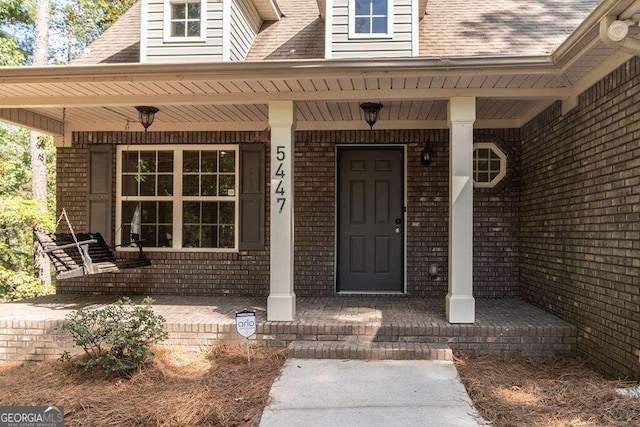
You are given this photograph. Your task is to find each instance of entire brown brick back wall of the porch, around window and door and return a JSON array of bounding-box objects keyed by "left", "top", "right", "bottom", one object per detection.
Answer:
[{"left": 58, "top": 130, "right": 519, "bottom": 297}]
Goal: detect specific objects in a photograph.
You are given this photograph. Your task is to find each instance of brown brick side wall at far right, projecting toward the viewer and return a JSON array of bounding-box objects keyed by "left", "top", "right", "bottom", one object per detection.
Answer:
[{"left": 520, "top": 58, "right": 640, "bottom": 377}]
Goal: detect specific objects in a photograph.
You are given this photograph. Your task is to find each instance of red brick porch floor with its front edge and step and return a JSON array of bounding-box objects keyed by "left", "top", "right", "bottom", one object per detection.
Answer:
[{"left": 0, "top": 295, "right": 577, "bottom": 361}]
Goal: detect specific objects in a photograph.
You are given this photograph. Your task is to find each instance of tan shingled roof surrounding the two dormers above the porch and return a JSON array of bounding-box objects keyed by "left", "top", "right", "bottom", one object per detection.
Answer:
[{"left": 74, "top": 0, "right": 600, "bottom": 64}]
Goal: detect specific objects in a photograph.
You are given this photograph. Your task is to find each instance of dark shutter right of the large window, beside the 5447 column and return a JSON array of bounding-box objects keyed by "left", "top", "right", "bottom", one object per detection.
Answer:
[{"left": 239, "top": 144, "right": 265, "bottom": 251}]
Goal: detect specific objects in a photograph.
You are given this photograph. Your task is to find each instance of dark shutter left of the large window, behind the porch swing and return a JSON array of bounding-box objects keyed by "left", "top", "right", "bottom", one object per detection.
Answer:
[{"left": 87, "top": 145, "right": 113, "bottom": 243}]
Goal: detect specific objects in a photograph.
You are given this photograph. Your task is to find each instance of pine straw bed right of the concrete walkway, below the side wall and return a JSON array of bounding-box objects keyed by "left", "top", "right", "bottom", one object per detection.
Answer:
[{"left": 456, "top": 356, "right": 640, "bottom": 427}]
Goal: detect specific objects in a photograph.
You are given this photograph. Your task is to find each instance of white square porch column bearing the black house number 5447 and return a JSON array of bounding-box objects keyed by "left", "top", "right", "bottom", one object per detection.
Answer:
[{"left": 267, "top": 101, "right": 296, "bottom": 321}]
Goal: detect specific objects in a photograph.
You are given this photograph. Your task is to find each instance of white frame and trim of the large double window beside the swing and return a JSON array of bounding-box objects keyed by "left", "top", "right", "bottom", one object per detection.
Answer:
[{"left": 115, "top": 144, "right": 240, "bottom": 253}]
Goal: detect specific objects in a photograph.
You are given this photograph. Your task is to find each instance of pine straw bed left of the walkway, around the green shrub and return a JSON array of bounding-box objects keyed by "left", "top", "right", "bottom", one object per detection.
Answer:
[{"left": 0, "top": 343, "right": 285, "bottom": 427}]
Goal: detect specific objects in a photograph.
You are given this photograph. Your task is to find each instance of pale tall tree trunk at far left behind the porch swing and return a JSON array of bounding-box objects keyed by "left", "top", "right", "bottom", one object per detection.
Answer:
[{"left": 31, "top": 0, "right": 51, "bottom": 285}]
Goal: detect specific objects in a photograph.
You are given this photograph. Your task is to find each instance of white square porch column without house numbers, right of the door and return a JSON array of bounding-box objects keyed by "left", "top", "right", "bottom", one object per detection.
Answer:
[{"left": 446, "top": 97, "right": 476, "bottom": 323}]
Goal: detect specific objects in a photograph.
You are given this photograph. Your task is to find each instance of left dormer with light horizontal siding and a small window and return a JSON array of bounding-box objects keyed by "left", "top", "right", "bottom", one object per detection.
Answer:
[{"left": 140, "top": 0, "right": 281, "bottom": 63}]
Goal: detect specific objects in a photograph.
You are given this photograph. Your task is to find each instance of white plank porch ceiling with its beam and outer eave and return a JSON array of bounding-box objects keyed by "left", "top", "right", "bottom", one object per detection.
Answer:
[{"left": 0, "top": 1, "right": 640, "bottom": 139}]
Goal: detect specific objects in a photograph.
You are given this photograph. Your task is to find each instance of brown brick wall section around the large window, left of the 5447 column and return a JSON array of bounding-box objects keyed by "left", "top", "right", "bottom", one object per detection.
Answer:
[{"left": 56, "top": 132, "right": 269, "bottom": 296}]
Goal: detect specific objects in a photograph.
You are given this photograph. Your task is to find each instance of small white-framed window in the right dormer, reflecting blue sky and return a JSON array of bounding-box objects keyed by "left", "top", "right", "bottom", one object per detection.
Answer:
[{"left": 349, "top": 0, "right": 393, "bottom": 38}]
